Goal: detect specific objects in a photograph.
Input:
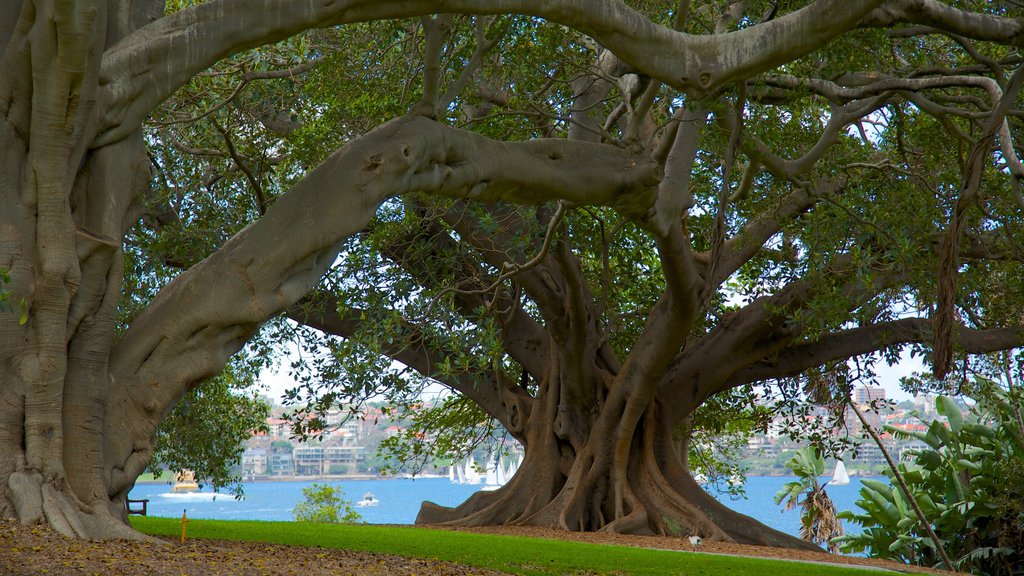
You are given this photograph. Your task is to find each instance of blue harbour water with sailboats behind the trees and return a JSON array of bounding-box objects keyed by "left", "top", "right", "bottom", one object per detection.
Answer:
[{"left": 130, "top": 477, "right": 884, "bottom": 535}]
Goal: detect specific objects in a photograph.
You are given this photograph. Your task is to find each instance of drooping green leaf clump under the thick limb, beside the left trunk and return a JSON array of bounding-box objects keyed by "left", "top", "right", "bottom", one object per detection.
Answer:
[{"left": 148, "top": 363, "right": 270, "bottom": 497}]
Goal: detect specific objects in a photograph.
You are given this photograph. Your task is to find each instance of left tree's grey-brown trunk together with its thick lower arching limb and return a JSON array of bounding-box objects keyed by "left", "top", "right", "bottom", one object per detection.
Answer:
[{"left": 0, "top": 0, "right": 658, "bottom": 538}]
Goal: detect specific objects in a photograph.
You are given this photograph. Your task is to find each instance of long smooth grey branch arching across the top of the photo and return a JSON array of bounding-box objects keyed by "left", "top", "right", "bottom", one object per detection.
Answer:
[{"left": 94, "top": 0, "right": 882, "bottom": 146}]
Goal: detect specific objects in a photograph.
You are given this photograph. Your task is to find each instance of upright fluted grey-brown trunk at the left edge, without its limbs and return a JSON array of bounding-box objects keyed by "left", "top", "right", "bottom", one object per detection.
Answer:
[{"left": 0, "top": 0, "right": 162, "bottom": 537}]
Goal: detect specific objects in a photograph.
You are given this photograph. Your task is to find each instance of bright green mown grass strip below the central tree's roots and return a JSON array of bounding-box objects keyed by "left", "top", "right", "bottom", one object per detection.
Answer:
[{"left": 131, "top": 517, "right": 879, "bottom": 576}]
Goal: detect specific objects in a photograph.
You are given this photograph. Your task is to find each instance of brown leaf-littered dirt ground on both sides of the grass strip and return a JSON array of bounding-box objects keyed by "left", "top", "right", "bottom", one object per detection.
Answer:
[{"left": 0, "top": 521, "right": 934, "bottom": 576}]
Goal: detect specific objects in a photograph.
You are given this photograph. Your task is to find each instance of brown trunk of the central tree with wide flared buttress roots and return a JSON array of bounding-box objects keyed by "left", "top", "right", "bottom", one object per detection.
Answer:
[{"left": 417, "top": 234, "right": 815, "bottom": 548}]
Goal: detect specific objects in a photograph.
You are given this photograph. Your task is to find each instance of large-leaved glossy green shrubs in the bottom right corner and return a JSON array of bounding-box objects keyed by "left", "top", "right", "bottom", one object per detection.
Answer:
[{"left": 839, "top": 377, "right": 1024, "bottom": 575}]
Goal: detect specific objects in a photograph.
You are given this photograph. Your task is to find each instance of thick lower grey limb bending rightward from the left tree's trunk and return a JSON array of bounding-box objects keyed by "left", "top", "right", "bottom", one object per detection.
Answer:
[{"left": 106, "top": 117, "right": 656, "bottom": 483}]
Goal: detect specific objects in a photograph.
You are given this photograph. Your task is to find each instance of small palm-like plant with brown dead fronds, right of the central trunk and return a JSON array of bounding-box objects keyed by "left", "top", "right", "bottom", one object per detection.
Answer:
[{"left": 775, "top": 446, "right": 843, "bottom": 552}]
